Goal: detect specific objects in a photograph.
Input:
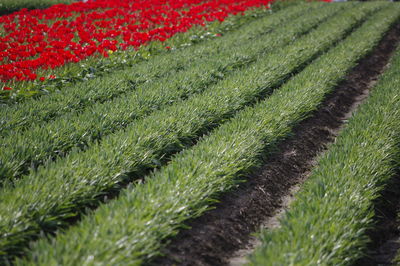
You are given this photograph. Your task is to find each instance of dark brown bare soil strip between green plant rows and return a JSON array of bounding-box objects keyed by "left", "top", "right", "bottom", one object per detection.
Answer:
[{"left": 150, "top": 24, "right": 400, "bottom": 265}]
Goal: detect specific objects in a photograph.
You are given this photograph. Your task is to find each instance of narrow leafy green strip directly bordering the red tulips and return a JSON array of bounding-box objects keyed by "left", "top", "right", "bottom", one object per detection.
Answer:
[{"left": 0, "top": 6, "right": 272, "bottom": 105}]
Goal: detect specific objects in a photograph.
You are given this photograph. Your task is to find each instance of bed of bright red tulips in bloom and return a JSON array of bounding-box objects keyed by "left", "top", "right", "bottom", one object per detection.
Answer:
[{"left": 0, "top": 0, "right": 270, "bottom": 82}]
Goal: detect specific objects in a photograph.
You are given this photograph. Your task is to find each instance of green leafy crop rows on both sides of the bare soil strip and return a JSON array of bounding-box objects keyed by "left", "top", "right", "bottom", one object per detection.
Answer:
[{"left": 0, "top": 1, "right": 400, "bottom": 265}]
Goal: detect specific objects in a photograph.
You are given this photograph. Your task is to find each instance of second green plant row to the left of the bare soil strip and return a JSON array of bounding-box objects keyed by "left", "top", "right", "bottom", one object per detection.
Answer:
[{"left": 0, "top": 3, "right": 382, "bottom": 261}]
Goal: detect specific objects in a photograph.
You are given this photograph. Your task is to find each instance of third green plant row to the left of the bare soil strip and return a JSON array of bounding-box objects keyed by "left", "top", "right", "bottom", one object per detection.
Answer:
[{"left": 0, "top": 2, "right": 341, "bottom": 180}]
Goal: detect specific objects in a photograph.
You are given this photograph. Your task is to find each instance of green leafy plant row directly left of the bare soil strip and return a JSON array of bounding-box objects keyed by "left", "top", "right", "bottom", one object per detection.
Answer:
[{"left": 16, "top": 4, "right": 400, "bottom": 265}]
